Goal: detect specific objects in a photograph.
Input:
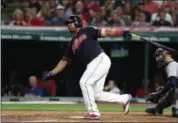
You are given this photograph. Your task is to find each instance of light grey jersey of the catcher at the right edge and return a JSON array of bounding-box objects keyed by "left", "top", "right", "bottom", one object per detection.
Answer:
[{"left": 166, "top": 61, "right": 178, "bottom": 78}]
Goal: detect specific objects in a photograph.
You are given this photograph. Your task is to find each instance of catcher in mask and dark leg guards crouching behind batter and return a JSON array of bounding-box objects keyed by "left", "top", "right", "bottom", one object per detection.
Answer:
[{"left": 146, "top": 48, "right": 178, "bottom": 117}]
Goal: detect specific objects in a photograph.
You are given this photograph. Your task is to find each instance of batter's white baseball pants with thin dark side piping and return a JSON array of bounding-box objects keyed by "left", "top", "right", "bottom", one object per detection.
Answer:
[{"left": 80, "top": 53, "right": 128, "bottom": 116}]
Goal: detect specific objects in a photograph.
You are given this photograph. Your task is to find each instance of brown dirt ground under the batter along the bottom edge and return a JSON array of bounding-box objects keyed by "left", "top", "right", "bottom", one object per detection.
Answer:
[{"left": 2, "top": 111, "right": 178, "bottom": 123}]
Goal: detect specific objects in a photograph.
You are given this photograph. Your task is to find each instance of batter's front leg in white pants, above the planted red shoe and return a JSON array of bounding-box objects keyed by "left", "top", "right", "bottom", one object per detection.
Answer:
[{"left": 80, "top": 54, "right": 109, "bottom": 116}]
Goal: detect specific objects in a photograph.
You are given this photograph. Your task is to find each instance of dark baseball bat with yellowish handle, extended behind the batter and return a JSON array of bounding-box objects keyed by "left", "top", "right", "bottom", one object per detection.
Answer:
[{"left": 131, "top": 33, "right": 178, "bottom": 54}]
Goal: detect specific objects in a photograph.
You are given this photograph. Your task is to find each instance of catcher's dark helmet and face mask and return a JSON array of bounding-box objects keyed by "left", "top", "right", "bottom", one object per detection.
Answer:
[{"left": 155, "top": 48, "right": 169, "bottom": 68}]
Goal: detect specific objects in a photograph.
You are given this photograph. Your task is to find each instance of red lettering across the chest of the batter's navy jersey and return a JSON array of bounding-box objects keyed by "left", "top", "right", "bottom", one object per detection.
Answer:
[{"left": 72, "top": 34, "right": 87, "bottom": 54}]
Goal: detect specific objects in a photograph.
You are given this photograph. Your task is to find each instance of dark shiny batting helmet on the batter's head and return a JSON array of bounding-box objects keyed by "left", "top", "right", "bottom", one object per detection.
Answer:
[{"left": 66, "top": 15, "right": 82, "bottom": 28}]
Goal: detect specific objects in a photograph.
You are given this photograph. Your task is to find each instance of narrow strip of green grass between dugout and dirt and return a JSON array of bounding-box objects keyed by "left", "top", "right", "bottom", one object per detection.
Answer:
[{"left": 1, "top": 104, "right": 171, "bottom": 112}]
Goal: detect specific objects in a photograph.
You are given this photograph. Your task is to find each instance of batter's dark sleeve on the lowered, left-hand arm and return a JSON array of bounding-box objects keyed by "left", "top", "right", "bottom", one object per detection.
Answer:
[{"left": 62, "top": 42, "right": 73, "bottom": 62}]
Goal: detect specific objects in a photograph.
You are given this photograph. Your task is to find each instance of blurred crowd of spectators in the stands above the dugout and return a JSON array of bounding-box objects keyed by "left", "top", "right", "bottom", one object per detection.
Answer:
[{"left": 1, "top": 0, "right": 178, "bottom": 27}]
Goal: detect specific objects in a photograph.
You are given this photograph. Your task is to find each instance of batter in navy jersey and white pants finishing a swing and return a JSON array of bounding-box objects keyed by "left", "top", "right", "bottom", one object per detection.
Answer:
[{"left": 44, "top": 15, "right": 131, "bottom": 119}]
